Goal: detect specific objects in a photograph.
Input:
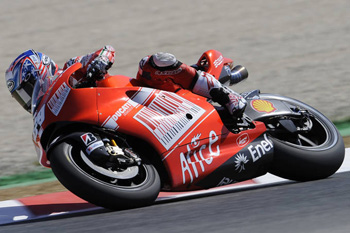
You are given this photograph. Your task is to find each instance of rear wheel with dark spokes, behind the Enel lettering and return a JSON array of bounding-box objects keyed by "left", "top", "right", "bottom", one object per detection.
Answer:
[{"left": 261, "top": 94, "right": 345, "bottom": 181}]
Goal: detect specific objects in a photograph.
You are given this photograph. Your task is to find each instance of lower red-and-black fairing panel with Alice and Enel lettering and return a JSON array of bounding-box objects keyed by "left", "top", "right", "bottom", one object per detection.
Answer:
[{"left": 163, "top": 122, "right": 273, "bottom": 191}]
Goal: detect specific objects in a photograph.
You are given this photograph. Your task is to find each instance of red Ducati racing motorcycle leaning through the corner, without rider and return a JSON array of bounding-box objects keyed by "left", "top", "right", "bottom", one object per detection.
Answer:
[{"left": 32, "top": 50, "right": 345, "bottom": 209}]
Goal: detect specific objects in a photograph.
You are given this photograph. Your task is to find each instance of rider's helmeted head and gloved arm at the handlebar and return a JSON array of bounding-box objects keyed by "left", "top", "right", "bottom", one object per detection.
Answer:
[{"left": 5, "top": 45, "right": 115, "bottom": 113}]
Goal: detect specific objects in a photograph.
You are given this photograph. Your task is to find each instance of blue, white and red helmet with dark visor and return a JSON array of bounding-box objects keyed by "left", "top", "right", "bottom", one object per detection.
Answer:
[{"left": 5, "top": 50, "right": 58, "bottom": 112}]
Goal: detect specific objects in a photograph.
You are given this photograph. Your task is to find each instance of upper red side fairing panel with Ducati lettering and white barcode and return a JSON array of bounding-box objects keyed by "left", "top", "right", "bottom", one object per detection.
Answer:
[{"left": 97, "top": 84, "right": 217, "bottom": 154}]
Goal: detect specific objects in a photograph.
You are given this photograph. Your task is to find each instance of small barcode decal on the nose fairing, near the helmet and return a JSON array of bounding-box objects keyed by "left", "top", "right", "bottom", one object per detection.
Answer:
[{"left": 47, "top": 83, "right": 70, "bottom": 116}]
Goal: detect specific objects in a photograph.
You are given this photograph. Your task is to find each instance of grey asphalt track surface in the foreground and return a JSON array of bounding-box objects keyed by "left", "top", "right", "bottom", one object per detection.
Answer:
[{"left": 0, "top": 172, "right": 350, "bottom": 233}]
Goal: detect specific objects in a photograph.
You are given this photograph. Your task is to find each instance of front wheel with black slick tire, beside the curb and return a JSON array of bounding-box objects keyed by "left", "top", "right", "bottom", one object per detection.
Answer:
[{"left": 50, "top": 142, "right": 160, "bottom": 209}]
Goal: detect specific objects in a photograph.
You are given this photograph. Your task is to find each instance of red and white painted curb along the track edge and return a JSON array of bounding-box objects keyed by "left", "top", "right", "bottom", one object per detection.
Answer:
[{"left": 0, "top": 148, "right": 350, "bottom": 226}]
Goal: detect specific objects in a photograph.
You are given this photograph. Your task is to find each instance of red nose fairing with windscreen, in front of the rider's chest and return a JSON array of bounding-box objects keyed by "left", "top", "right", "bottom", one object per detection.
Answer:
[{"left": 32, "top": 63, "right": 98, "bottom": 167}]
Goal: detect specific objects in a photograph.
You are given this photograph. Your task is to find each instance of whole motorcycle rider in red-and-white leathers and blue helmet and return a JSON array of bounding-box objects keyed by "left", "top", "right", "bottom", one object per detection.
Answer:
[{"left": 5, "top": 45, "right": 246, "bottom": 118}]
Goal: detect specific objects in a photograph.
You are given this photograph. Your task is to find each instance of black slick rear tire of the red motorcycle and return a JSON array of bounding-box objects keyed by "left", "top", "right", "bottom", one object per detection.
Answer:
[{"left": 261, "top": 94, "right": 345, "bottom": 181}]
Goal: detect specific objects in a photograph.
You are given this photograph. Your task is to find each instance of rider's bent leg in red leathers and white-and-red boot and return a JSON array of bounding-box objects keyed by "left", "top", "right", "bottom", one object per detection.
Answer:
[{"left": 137, "top": 52, "right": 247, "bottom": 118}]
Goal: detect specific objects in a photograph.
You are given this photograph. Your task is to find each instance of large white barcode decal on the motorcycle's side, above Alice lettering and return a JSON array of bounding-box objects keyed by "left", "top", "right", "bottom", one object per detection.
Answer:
[{"left": 134, "top": 91, "right": 205, "bottom": 150}]
